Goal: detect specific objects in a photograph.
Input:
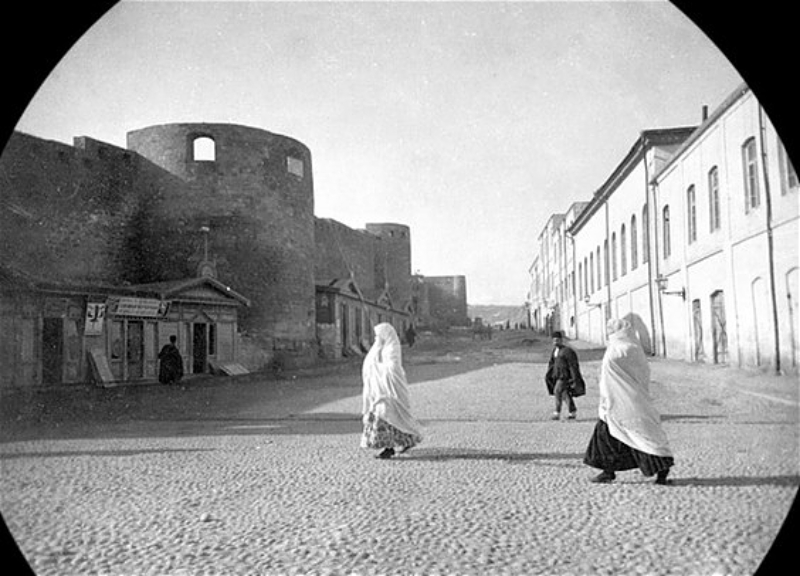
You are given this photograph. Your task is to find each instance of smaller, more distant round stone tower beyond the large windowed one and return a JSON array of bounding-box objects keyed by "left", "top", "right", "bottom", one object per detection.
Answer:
[{"left": 366, "top": 223, "right": 412, "bottom": 309}]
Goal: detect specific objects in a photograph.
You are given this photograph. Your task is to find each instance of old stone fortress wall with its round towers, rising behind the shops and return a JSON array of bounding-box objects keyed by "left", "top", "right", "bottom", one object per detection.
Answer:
[{"left": 0, "top": 123, "right": 466, "bottom": 385}]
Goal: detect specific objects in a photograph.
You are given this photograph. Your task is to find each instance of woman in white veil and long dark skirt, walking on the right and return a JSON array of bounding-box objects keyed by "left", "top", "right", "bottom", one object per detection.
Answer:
[{"left": 583, "top": 319, "right": 674, "bottom": 484}]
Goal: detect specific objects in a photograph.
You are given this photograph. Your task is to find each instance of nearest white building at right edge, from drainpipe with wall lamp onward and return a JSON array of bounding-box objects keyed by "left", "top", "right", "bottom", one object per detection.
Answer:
[{"left": 652, "top": 85, "right": 800, "bottom": 370}]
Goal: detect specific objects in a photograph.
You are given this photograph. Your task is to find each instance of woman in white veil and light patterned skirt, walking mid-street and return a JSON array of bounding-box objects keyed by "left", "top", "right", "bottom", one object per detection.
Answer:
[{"left": 361, "top": 323, "right": 422, "bottom": 459}]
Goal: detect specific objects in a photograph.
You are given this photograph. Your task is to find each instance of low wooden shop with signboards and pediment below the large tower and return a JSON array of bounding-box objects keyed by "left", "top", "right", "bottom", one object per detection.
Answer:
[{"left": 0, "top": 268, "right": 250, "bottom": 389}]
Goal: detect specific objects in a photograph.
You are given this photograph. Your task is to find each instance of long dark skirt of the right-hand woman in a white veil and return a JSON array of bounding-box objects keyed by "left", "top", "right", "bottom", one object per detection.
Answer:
[{"left": 583, "top": 420, "right": 675, "bottom": 476}]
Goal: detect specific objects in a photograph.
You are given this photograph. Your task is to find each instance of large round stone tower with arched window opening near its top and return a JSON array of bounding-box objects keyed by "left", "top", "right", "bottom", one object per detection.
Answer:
[{"left": 127, "top": 123, "right": 315, "bottom": 356}]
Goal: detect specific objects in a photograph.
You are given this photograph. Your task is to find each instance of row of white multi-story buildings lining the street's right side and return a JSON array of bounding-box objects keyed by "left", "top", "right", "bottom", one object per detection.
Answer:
[{"left": 531, "top": 85, "right": 800, "bottom": 370}]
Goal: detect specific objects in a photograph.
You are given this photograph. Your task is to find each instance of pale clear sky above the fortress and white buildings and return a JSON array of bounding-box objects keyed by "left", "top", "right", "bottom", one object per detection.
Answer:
[{"left": 10, "top": 0, "right": 742, "bottom": 306}]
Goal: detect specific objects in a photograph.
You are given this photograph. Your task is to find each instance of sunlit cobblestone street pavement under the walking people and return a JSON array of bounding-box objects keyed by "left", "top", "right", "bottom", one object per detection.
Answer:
[{"left": 0, "top": 338, "right": 800, "bottom": 576}]
